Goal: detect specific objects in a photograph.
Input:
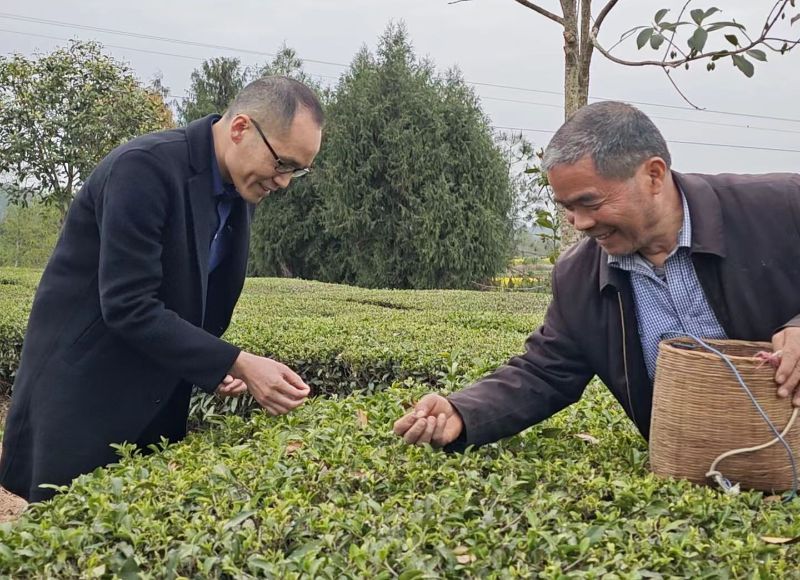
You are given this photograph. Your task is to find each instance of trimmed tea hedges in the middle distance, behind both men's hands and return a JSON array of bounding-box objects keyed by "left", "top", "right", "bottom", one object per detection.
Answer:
[{"left": 0, "top": 269, "right": 549, "bottom": 401}]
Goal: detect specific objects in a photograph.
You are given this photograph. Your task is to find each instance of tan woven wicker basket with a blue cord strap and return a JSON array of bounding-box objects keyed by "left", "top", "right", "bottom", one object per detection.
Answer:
[{"left": 650, "top": 338, "right": 800, "bottom": 492}]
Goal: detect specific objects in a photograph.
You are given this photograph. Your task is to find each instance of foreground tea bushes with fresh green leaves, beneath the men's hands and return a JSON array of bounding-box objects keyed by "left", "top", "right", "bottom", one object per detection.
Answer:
[{"left": 0, "top": 385, "right": 800, "bottom": 578}]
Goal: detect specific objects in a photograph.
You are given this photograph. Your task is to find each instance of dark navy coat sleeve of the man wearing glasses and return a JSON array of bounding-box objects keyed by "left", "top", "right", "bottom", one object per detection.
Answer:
[{"left": 95, "top": 149, "right": 240, "bottom": 391}]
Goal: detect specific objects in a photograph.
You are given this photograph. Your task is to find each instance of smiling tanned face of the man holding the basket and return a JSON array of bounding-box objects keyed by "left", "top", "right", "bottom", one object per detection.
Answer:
[{"left": 547, "top": 156, "right": 660, "bottom": 255}]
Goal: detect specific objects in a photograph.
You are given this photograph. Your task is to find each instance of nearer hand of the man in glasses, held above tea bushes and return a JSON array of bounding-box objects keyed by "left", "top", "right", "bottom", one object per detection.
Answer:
[{"left": 229, "top": 351, "right": 311, "bottom": 415}]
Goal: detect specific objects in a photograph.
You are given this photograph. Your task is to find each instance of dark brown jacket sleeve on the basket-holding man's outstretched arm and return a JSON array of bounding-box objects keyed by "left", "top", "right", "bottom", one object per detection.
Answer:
[{"left": 447, "top": 272, "right": 594, "bottom": 451}]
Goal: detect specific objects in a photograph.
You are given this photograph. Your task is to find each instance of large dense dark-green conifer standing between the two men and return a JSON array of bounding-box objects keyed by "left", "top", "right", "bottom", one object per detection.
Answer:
[{"left": 247, "top": 26, "right": 513, "bottom": 288}]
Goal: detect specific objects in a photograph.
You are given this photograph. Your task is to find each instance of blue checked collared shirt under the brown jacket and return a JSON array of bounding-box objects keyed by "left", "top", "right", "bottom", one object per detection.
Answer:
[{"left": 608, "top": 195, "right": 727, "bottom": 381}]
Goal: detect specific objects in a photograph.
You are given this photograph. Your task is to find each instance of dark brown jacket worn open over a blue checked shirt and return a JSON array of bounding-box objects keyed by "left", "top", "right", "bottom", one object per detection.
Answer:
[{"left": 449, "top": 172, "right": 800, "bottom": 449}]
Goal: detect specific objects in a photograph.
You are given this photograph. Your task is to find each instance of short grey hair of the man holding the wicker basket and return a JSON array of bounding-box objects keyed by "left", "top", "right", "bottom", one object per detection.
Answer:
[{"left": 542, "top": 101, "right": 672, "bottom": 179}]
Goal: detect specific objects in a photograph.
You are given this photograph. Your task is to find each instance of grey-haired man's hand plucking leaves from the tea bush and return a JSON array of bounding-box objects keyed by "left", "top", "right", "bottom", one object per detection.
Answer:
[{"left": 394, "top": 394, "right": 464, "bottom": 447}]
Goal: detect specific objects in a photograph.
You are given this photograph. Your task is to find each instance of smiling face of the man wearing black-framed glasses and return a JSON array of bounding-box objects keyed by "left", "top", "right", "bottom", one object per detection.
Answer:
[{"left": 226, "top": 108, "right": 322, "bottom": 204}]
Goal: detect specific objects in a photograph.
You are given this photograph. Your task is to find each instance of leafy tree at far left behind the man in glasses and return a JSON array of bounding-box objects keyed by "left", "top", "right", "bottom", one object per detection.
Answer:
[{"left": 0, "top": 41, "right": 172, "bottom": 216}]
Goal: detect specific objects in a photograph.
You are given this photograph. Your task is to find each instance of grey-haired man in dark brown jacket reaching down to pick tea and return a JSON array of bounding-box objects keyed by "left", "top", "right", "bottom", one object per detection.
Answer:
[{"left": 394, "top": 102, "right": 800, "bottom": 450}]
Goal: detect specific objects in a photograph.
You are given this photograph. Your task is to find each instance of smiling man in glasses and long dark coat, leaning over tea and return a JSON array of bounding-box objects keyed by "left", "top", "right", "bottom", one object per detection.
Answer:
[{"left": 0, "top": 77, "right": 323, "bottom": 501}]
